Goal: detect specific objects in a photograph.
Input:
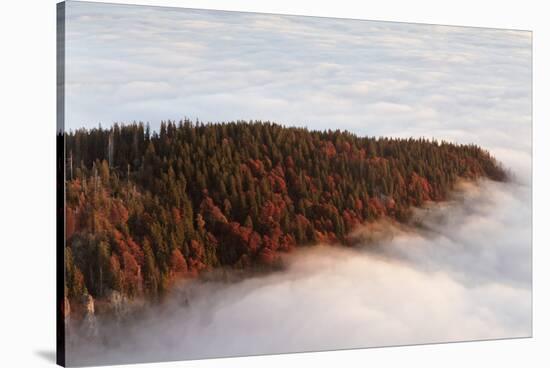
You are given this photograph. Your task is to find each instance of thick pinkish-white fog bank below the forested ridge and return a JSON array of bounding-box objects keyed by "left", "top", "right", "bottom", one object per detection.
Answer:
[{"left": 67, "top": 181, "right": 531, "bottom": 365}]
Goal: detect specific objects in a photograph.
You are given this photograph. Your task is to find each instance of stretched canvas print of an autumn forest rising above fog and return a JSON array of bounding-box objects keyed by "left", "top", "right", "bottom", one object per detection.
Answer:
[{"left": 57, "top": 1, "right": 532, "bottom": 366}]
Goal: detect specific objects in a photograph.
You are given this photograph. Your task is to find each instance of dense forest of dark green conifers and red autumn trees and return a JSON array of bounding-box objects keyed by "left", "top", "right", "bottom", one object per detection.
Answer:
[{"left": 65, "top": 121, "right": 506, "bottom": 308}]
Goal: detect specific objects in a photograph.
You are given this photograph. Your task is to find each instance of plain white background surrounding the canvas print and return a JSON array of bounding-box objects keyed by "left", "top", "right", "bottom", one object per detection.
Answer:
[{"left": 0, "top": 0, "right": 550, "bottom": 368}]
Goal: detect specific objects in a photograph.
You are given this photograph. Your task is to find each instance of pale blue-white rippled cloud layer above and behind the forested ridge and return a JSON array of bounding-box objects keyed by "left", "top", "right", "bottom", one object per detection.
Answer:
[{"left": 65, "top": 1, "right": 532, "bottom": 174}]
